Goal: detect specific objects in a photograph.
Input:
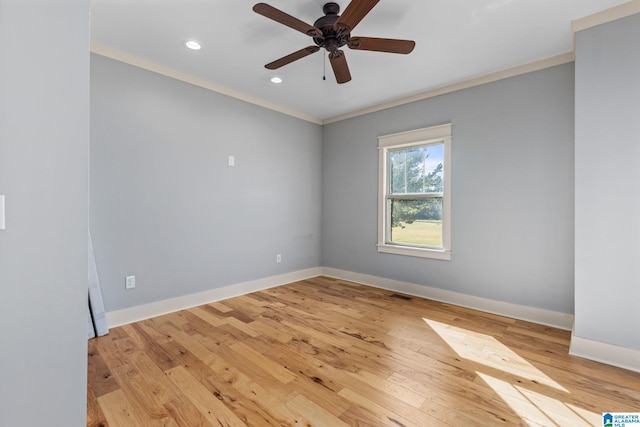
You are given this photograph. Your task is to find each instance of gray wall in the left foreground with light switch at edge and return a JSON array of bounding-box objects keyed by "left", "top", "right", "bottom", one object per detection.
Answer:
[{"left": 0, "top": 0, "right": 89, "bottom": 426}]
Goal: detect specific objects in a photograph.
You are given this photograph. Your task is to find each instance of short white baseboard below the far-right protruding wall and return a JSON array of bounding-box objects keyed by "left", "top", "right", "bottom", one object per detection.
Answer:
[{"left": 569, "top": 334, "right": 640, "bottom": 372}]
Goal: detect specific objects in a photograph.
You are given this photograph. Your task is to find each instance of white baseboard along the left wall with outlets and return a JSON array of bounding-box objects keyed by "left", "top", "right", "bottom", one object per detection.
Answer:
[{"left": 107, "top": 267, "right": 322, "bottom": 328}]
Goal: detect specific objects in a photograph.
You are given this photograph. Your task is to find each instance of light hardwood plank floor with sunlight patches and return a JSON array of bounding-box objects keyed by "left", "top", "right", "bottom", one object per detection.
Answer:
[{"left": 87, "top": 277, "right": 640, "bottom": 427}]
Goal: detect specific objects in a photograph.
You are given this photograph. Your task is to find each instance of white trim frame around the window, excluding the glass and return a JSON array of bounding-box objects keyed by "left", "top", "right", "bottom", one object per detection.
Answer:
[{"left": 378, "top": 123, "right": 452, "bottom": 260}]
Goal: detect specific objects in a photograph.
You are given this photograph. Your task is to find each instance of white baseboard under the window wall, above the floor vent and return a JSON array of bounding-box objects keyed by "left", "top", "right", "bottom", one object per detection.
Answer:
[{"left": 322, "top": 267, "right": 573, "bottom": 331}]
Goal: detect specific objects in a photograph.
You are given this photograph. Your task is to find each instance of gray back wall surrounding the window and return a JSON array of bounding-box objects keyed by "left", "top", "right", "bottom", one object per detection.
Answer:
[{"left": 322, "top": 64, "right": 574, "bottom": 313}]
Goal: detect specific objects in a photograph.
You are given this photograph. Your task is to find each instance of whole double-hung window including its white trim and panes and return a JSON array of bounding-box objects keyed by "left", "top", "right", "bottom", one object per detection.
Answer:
[{"left": 378, "top": 124, "right": 451, "bottom": 260}]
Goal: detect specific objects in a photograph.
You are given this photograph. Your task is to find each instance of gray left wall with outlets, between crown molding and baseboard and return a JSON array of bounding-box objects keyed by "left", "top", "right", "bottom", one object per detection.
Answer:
[{"left": 90, "top": 55, "right": 322, "bottom": 311}]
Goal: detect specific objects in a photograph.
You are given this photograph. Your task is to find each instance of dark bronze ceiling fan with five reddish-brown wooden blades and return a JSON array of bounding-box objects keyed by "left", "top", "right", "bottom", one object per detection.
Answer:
[{"left": 253, "top": 0, "right": 416, "bottom": 83}]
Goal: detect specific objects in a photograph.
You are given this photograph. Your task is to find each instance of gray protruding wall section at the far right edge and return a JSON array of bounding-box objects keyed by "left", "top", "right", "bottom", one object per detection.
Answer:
[{"left": 574, "top": 14, "right": 640, "bottom": 350}]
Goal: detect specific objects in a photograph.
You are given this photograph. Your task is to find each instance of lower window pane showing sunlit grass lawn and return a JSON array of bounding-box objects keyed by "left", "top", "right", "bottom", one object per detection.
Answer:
[{"left": 390, "top": 198, "right": 442, "bottom": 248}]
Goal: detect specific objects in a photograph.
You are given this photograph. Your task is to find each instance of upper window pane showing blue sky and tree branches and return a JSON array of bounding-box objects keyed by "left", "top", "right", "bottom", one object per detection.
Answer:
[{"left": 388, "top": 144, "right": 444, "bottom": 194}]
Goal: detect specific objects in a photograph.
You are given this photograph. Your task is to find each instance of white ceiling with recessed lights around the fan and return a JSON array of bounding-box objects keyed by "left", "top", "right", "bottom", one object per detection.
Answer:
[{"left": 91, "top": 0, "right": 625, "bottom": 120}]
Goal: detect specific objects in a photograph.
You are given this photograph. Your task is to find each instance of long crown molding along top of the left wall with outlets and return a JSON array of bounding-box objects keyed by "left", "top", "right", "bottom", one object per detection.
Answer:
[{"left": 91, "top": 42, "right": 322, "bottom": 125}]
